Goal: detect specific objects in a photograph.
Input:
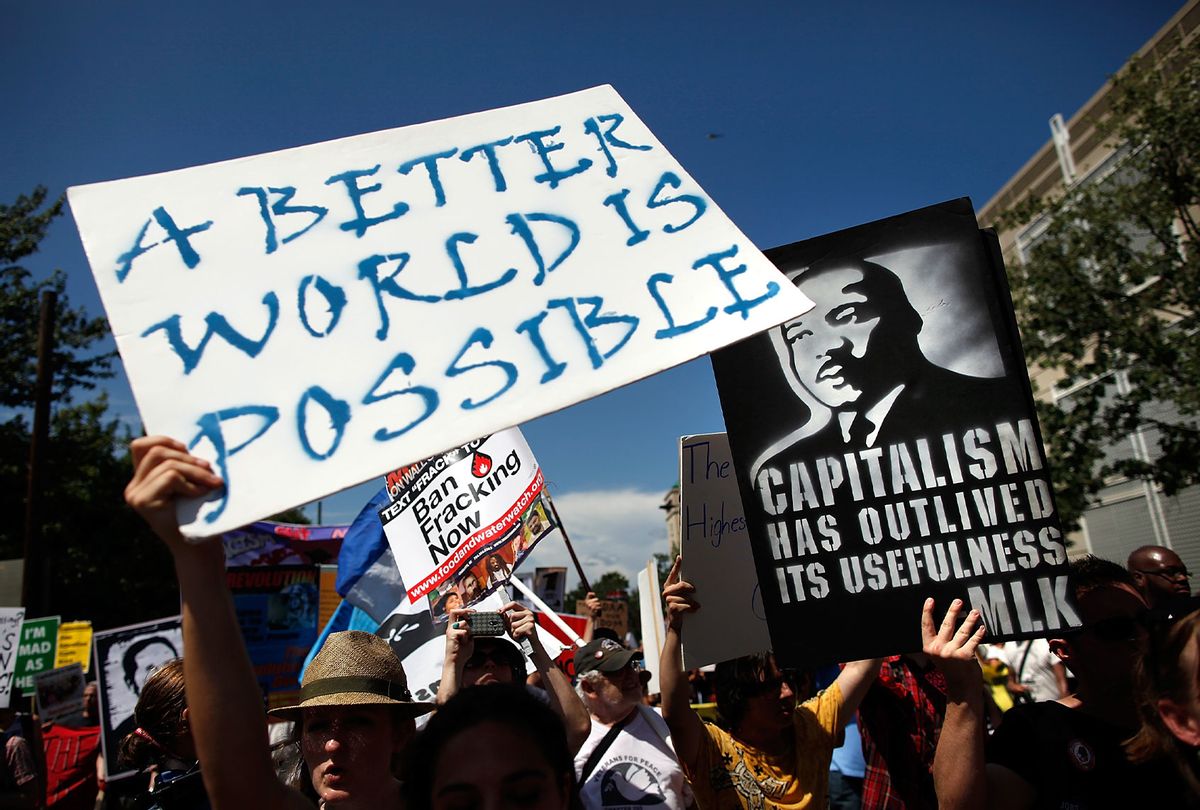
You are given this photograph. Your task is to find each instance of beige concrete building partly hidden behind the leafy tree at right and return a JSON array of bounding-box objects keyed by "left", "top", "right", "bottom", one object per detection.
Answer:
[{"left": 978, "top": 0, "right": 1200, "bottom": 573}]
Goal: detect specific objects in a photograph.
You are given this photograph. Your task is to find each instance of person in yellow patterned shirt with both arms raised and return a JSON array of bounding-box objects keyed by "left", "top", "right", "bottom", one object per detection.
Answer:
[{"left": 659, "top": 557, "right": 882, "bottom": 810}]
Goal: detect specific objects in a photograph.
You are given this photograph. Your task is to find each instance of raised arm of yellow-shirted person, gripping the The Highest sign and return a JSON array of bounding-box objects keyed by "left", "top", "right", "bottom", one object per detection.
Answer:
[{"left": 659, "top": 557, "right": 707, "bottom": 772}]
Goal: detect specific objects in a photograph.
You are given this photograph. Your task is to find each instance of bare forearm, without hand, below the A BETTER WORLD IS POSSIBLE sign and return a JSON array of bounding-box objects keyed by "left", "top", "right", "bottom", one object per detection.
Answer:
[{"left": 175, "top": 546, "right": 282, "bottom": 810}]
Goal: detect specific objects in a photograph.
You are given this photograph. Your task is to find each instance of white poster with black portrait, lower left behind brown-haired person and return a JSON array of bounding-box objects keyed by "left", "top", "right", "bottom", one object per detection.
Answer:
[{"left": 92, "top": 616, "right": 184, "bottom": 780}]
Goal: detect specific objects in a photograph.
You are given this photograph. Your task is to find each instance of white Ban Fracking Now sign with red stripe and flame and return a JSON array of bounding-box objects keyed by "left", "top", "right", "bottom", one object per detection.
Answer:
[{"left": 379, "top": 428, "right": 553, "bottom": 618}]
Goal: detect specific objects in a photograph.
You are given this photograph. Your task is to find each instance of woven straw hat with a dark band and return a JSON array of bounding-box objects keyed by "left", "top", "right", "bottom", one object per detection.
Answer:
[{"left": 270, "top": 630, "right": 434, "bottom": 720}]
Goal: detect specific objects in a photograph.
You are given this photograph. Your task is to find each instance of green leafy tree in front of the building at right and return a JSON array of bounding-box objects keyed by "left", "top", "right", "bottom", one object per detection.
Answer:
[{"left": 1002, "top": 42, "right": 1200, "bottom": 524}]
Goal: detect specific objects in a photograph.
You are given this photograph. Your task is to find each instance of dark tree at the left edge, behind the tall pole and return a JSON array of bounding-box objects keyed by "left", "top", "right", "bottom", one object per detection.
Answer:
[{"left": 0, "top": 188, "right": 179, "bottom": 629}]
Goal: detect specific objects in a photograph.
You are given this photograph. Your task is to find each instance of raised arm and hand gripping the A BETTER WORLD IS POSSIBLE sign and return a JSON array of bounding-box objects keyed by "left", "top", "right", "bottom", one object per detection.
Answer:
[{"left": 125, "top": 437, "right": 311, "bottom": 810}]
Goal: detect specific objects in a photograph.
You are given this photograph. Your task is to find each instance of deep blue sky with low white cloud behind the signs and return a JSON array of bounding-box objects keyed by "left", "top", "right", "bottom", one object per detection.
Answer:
[{"left": 0, "top": 0, "right": 1180, "bottom": 595}]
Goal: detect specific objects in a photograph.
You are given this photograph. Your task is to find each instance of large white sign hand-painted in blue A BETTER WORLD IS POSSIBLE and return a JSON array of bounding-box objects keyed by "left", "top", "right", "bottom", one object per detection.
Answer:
[{"left": 68, "top": 86, "right": 810, "bottom": 535}]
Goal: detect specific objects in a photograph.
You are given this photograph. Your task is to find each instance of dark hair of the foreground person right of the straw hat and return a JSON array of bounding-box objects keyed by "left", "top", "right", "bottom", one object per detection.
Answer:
[{"left": 402, "top": 684, "right": 581, "bottom": 810}]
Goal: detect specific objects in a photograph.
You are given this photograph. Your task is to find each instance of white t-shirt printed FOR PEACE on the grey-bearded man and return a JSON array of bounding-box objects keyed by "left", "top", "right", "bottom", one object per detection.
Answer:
[{"left": 575, "top": 706, "right": 692, "bottom": 810}]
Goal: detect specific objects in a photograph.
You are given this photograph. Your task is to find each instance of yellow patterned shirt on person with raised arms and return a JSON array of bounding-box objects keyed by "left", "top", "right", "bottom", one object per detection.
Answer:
[{"left": 684, "top": 684, "right": 842, "bottom": 810}]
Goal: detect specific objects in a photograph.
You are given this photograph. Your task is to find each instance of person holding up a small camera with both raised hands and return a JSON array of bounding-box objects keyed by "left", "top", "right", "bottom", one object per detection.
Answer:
[{"left": 437, "top": 602, "right": 592, "bottom": 752}]
